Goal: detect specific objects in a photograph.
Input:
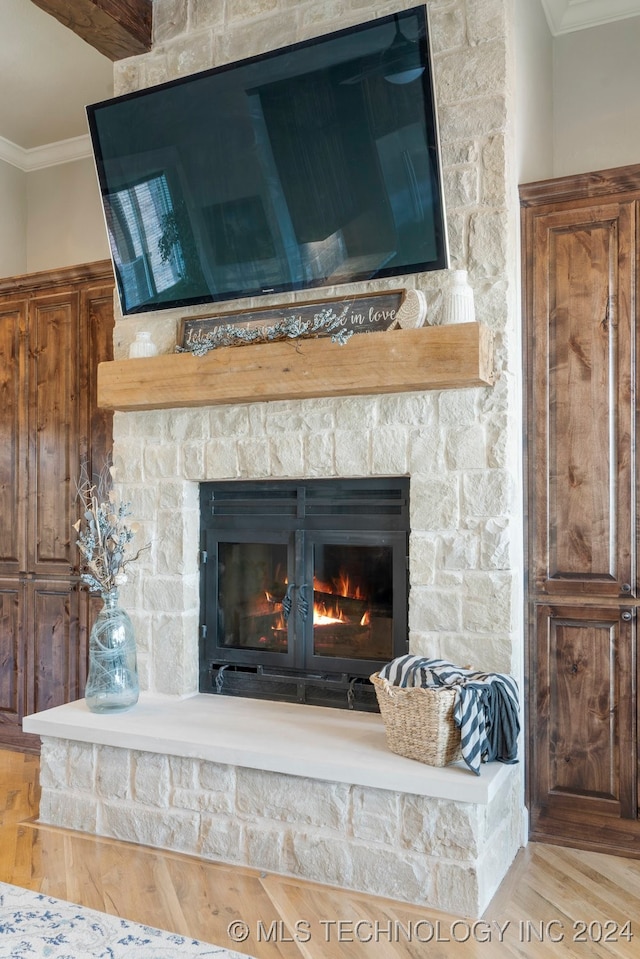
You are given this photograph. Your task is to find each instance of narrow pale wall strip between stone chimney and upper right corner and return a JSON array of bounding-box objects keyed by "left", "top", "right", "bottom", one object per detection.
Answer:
[{"left": 515, "top": 0, "right": 553, "bottom": 183}]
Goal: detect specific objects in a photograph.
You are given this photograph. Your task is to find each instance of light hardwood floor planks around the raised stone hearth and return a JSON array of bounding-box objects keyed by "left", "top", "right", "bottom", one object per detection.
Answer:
[{"left": 0, "top": 749, "right": 640, "bottom": 959}]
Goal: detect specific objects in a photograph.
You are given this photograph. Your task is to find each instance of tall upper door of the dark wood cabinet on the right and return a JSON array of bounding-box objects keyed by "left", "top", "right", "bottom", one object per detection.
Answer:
[{"left": 527, "top": 200, "right": 636, "bottom": 597}]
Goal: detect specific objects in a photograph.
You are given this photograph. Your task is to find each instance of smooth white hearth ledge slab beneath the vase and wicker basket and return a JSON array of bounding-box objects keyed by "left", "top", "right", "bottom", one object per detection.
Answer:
[{"left": 23, "top": 693, "right": 510, "bottom": 805}]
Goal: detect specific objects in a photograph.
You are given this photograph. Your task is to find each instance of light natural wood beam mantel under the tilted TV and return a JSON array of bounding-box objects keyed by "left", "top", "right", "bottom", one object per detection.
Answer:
[{"left": 98, "top": 323, "right": 494, "bottom": 410}]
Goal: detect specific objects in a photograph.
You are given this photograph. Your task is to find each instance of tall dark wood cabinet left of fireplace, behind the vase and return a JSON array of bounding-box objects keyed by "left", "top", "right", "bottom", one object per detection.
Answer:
[{"left": 0, "top": 262, "right": 114, "bottom": 748}]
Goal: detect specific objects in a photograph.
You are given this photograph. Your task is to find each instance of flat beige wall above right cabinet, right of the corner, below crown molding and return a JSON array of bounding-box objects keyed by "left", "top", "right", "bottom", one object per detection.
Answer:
[{"left": 553, "top": 17, "right": 640, "bottom": 176}]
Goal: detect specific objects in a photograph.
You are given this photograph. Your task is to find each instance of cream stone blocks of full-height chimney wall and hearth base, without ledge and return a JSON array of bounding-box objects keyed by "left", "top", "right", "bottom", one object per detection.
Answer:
[{"left": 33, "top": 0, "right": 523, "bottom": 913}]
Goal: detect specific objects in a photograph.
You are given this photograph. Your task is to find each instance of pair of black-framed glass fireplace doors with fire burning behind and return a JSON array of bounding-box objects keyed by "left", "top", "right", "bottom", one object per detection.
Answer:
[{"left": 206, "top": 530, "right": 406, "bottom": 675}]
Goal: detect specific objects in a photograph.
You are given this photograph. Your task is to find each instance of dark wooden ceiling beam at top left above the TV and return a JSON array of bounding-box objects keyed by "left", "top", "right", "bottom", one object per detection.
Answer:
[{"left": 32, "top": 0, "right": 153, "bottom": 60}]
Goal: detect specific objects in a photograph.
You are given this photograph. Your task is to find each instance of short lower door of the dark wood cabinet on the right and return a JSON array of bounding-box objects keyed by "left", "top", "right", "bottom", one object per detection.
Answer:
[{"left": 528, "top": 605, "right": 640, "bottom": 855}]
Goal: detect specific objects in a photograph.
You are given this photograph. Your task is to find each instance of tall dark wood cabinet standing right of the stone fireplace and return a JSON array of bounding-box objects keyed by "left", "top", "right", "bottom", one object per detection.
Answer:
[{"left": 521, "top": 167, "right": 640, "bottom": 856}]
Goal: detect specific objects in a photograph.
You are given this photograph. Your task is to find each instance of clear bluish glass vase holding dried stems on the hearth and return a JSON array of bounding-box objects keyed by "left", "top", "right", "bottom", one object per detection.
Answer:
[{"left": 84, "top": 589, "right": 140, "bottom": 713}]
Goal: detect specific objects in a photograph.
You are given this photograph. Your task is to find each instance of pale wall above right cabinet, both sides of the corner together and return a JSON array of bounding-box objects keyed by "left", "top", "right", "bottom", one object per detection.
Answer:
[{"left": 515, "top": 6, "right": 640, "bottom": 183}]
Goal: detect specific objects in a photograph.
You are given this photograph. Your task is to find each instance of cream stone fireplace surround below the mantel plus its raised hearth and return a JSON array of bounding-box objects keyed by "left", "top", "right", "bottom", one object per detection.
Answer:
[{"left": 25, "top": 380, "right": 523, "bottom": 915}]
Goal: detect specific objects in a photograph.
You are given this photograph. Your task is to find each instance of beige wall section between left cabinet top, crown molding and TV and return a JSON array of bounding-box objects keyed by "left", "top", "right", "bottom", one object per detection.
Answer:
[{"left": 26, "top": 159, "right": 109, "bottom": 273}]
